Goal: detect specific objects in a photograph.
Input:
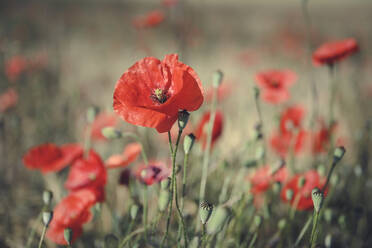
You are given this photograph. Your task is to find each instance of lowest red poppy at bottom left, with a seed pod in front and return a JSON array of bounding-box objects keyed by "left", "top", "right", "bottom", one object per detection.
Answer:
[{"left": 46, "top": 189, "right": 97, "bottom": 245}]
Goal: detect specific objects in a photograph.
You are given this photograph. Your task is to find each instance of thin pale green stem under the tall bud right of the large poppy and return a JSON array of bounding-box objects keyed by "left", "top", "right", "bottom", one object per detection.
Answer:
[{"left": 196, "top": 84, "right": 218, "bottom": 230}]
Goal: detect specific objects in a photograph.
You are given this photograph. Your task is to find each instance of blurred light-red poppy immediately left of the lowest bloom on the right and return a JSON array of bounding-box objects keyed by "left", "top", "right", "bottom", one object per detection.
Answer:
[{"left": 248, "top": 165, "right": 288, "bottom": 194}]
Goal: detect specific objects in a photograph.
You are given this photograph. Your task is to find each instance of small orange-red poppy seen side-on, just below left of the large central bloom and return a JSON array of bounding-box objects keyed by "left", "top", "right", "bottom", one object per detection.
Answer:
[{"left": 105, "top": 142, "right": 142, "bottom": 169}]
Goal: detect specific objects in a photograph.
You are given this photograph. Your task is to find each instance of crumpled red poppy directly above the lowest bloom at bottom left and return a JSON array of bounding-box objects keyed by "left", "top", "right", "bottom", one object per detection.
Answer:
[{"left": 65, "top": 150, "right": 107, "bottom": 191}]
